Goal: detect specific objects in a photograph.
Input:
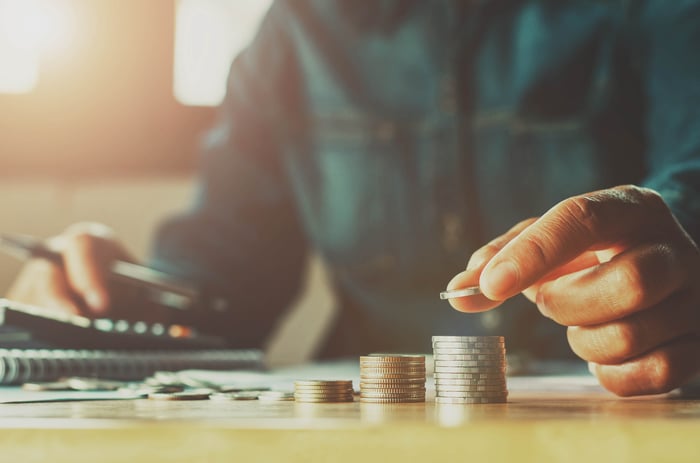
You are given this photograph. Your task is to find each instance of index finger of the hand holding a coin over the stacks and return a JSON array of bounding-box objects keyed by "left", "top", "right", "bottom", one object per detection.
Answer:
[{"left": 479, "top": 186, "right": 668, "bottom": 300}]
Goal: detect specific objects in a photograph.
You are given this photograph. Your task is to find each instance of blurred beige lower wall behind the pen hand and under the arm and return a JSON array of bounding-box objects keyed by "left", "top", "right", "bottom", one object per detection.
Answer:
[{"left": 0, "top": 177, "right": 333, "bottom": 365}]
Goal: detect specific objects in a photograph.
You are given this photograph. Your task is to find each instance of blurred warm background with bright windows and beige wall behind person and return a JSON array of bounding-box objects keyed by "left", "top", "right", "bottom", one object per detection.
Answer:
[{"left": 0, "top": 0, "right": 333, "bottom": 364}]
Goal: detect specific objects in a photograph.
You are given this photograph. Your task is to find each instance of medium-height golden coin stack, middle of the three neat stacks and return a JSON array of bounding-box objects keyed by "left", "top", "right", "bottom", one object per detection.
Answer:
[{"left": 360, "top": 354, "right": 425, "bottom": 403}]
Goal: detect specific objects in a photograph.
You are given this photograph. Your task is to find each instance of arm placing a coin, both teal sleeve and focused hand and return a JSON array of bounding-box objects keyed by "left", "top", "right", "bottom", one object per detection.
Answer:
[{"left": 448, "top": 0, "right": 700, "bottom": 395}]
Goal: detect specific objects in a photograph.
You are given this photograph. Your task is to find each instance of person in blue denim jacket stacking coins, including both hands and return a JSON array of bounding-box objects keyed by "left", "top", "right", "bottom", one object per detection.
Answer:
[{"left": 5, "top": 0, "right": 700, "bottom": 395}]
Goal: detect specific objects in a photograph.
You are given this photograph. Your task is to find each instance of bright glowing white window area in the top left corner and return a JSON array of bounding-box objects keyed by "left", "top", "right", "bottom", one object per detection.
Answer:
[{"left": 0, "top": 0, "right": 73, "bottom": 93}]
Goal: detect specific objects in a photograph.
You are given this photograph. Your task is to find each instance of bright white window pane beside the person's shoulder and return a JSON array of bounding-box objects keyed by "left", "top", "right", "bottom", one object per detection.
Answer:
[{"left": 174, "top": 0, "right": 272, "bottom": 106}]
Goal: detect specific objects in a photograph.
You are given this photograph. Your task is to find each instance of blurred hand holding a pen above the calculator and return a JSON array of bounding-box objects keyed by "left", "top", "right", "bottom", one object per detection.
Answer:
[{"left": 7, "top": 223, "right": 131, "bottom": 317}]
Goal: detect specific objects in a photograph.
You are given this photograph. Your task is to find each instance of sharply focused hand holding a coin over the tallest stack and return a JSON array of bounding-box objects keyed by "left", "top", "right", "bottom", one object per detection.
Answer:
[{"left": 448, "top": 186, "right": 700, "bottom": 396}]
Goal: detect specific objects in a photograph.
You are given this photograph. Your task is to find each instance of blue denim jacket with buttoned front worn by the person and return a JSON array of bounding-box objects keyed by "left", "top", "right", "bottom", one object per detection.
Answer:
[{"left": 150, "top": 0, "right": 700, "bottom": 357}]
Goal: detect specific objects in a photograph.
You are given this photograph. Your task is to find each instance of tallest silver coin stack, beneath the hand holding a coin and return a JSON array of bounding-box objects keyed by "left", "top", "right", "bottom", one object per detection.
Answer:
[{"left": 433, "top": 336, "right": 508, "bottom": 404}]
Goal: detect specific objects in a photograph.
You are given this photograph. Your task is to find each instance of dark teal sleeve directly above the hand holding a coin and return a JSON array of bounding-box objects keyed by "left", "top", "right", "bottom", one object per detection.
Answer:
[{"left": 640, "top": 0, "right": 700, "bottom": 244}]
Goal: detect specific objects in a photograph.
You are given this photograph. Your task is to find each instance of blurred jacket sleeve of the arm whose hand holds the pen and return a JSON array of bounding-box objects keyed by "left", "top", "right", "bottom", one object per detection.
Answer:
[{"left": 152, "top": 1, "right": 307, "bottom": 347}]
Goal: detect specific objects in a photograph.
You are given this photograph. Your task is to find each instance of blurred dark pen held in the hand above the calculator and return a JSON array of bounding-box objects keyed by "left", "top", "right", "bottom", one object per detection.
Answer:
[{"left": 0, "top": 234, "right": 199, "bottom": 309}]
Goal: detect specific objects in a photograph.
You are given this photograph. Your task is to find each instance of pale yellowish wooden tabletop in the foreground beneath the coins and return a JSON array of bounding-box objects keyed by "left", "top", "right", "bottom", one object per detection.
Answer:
[{"left": 0, "top": 380, "right": 700, "bottom": 463}]
